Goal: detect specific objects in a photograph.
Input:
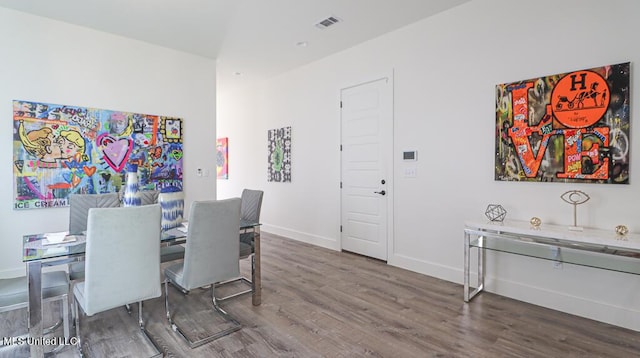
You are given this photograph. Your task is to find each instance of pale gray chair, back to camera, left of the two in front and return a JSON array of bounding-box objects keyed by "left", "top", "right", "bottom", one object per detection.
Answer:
[{"left": 73, "top": 204, "right": 162, "bottom": 353}]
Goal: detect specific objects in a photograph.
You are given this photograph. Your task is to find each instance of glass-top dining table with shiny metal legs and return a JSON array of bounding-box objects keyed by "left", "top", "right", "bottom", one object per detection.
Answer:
[{"left": 22, "top": 220, "right": 262, "bottom": 357}]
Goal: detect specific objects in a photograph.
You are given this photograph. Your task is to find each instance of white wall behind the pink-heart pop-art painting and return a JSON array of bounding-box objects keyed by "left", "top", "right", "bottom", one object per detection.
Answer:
[{"left": 0, "top": 8, "right": 216, "bottom": 277}]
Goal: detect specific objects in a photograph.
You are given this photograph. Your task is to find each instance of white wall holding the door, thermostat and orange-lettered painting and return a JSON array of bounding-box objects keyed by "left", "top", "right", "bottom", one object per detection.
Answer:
[{"left": 218, "top": 0, "right": 640, "bottom": 330}]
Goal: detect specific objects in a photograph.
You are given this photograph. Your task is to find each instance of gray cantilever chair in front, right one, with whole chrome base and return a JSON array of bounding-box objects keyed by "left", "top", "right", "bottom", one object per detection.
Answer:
[{"left": 164, "top": 198, "right": 241, "bottom": 348}]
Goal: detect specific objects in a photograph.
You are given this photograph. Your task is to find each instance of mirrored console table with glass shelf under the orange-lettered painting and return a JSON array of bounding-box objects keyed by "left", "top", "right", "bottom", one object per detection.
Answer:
[{"left": 464, "top": 220, "right": 640, "bottom": 302}]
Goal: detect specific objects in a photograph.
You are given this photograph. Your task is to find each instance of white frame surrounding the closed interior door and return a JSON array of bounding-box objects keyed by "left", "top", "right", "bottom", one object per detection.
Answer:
[{"left": 338, "top": 70, "right": 395, "bottom": 263}]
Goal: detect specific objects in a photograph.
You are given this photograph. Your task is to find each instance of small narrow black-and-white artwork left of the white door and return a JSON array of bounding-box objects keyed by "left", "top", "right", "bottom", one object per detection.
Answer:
[{"left": 267, "top": 127, "right": 291, "bottom": 183}]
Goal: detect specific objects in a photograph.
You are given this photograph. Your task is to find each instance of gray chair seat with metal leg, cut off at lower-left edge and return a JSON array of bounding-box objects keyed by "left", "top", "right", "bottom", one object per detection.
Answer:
[{"left": 0, "top": 271, "right": 70, "bottom": 345}]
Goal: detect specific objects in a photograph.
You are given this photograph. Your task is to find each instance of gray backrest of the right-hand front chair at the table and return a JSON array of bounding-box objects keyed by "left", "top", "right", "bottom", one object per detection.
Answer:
[{"left": 176, "top": 198, "right": 241, "bottom": 290}]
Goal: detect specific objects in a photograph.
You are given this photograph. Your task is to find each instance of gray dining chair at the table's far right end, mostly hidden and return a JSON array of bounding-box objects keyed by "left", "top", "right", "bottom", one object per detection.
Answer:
[{"left": 218, "top": 189, "right": 264, "bottom": 301}]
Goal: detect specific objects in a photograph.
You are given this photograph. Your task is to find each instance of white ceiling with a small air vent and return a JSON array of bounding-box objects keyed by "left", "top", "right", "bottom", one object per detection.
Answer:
[{"left": 0, "top": 0, "right": 470, "bottom": 83}]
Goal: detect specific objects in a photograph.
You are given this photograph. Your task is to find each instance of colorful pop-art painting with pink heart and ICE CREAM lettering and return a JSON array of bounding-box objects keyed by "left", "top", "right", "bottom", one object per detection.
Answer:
[{"left": 13, "top": 101, "right": 182, "bottom": 209}]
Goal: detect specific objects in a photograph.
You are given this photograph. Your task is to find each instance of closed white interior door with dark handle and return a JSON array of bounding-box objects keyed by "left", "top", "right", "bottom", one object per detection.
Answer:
[{"left": 340, "top": 78, "right": 393, "bottom": 261}]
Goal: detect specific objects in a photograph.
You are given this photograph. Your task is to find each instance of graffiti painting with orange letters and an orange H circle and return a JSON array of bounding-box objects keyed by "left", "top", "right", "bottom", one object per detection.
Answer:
[{"left": 495, "top": 62, "right": 630, "bottom": 184}]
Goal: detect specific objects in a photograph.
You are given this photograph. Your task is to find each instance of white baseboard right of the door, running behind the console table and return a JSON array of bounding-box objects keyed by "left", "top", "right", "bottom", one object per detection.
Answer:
[{"left": 387, "top": 254, "right": 640, "bottom": 332}]
